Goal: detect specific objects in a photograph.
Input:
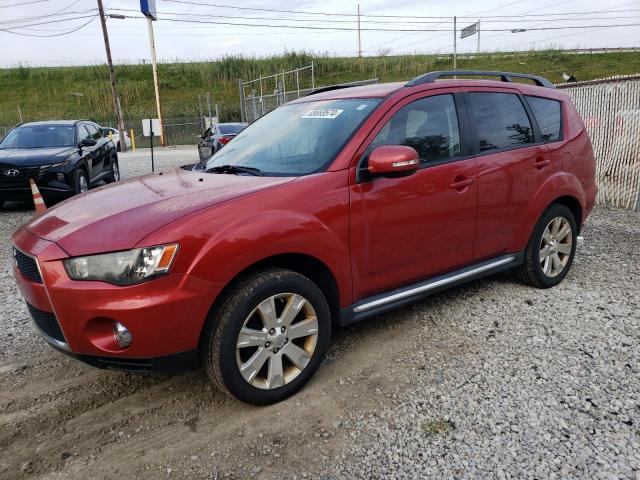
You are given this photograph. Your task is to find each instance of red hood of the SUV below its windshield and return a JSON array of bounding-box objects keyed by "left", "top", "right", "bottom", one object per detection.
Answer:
[{"left": 24, "top": 169, "right": 293, "bottom": 256}]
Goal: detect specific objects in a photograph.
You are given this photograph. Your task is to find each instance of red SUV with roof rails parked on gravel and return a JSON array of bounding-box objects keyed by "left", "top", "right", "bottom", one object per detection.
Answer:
[{"left": 13, "top": 71, "right": 597, "bottom": 404}]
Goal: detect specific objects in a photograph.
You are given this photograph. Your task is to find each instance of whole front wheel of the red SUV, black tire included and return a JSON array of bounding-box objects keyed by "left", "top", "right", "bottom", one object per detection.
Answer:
[{"left": 202, "top": 269, "right": 331, "bottom": 405}]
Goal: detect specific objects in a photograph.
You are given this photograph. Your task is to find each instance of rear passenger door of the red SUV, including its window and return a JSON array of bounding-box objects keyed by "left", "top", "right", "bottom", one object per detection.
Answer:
[{"left": 465, "top": 87, "right": 551, "bottom": 260}]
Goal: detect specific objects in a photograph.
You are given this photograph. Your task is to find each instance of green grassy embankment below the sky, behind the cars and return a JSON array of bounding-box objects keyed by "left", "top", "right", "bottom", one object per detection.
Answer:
[{"left": 0, "top": 50, "right": 640, "bottom": 129}]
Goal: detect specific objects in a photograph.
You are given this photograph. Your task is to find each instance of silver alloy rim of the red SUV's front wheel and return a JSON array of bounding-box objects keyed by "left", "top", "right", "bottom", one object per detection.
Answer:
[{"left": 236, "top": 293, "right": 318, "bottom": 390}]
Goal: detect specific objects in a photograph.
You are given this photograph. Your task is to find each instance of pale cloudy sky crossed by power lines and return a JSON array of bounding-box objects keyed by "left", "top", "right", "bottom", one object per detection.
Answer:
[{"left": 0, "top": 0, "right": 640, "bottom": 67}]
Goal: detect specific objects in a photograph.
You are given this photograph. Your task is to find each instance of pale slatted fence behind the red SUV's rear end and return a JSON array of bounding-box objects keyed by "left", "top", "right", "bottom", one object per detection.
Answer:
[{"left": 558, "top": 75, "right": 640, "bottom": 209}]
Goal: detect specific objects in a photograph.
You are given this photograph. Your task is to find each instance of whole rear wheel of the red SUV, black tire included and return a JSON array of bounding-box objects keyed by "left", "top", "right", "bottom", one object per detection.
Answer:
[{"left": 515, "top": 203, "right": 578, "bottom": 288}]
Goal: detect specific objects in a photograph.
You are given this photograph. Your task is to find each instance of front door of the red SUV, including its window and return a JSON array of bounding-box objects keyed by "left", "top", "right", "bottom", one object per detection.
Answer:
[{"left": 350, "top": 89, "right": 477, "bottom": 298}]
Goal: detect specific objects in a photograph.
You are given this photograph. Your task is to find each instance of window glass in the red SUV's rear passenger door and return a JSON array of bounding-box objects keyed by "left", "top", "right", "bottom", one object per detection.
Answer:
[{"left": 469, "top": 92, "right": 533, "bottom": 152}]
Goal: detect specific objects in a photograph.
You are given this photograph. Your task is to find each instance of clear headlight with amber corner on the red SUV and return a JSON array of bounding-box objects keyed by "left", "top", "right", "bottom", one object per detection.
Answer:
[{"left": 63, "top": 243, "right": 178, "bottom": 285}]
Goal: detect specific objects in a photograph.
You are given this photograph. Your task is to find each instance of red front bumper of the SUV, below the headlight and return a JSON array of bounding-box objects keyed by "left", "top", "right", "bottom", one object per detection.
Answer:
[{"left": 13, "top": 229, "right": 219, "bottom": 371}]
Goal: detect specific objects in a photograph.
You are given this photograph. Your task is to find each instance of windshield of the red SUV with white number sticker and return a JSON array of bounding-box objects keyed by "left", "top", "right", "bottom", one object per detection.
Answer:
[{"left": 206, "top": 99, "right": 381, "bottom": 176}]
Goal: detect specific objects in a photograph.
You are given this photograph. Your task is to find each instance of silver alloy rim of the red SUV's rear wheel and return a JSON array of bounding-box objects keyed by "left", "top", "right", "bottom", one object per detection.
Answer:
[{"left": 539, "top": 217, "right": 573, "bottom": 277}]
